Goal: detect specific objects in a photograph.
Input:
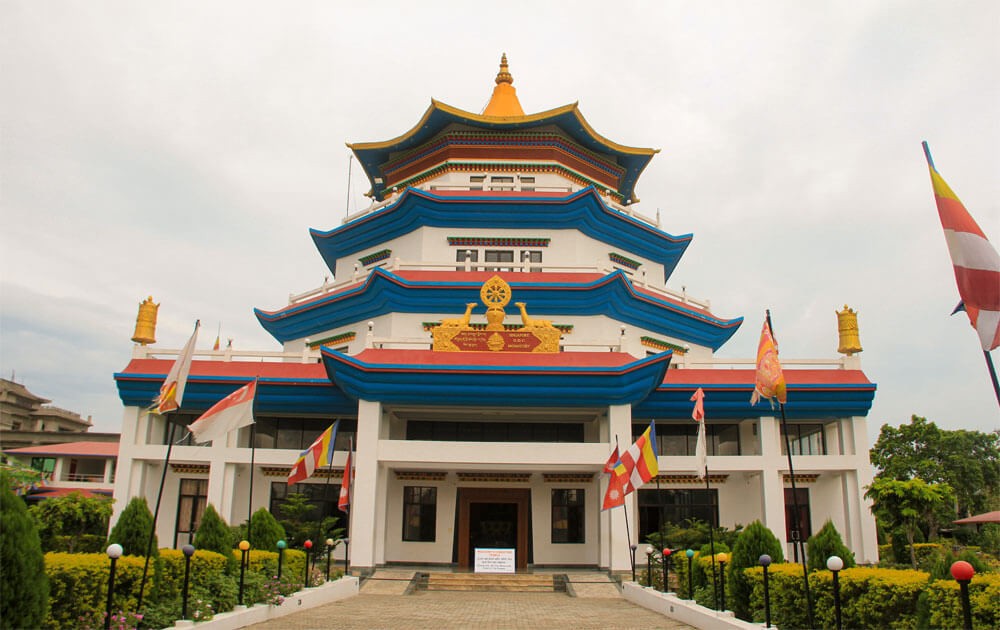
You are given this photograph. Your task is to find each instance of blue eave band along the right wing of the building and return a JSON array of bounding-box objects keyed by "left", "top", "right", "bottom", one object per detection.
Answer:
[{"left": 632, "top": 383, "right": 876, "bottom": 421}]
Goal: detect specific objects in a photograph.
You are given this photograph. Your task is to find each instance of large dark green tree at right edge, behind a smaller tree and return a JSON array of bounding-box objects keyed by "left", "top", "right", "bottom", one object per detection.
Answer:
[{"left": 871, "top": 416, "right": 1000, "bottom": 520}]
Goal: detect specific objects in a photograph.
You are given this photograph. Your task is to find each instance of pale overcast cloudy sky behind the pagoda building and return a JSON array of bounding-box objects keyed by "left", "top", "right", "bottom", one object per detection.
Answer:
[{"left": 0, "top": 0, "right": 1000, "bottom": 440}]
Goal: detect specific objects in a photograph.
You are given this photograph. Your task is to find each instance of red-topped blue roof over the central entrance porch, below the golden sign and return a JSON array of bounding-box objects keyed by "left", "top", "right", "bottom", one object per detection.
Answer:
[{"left": 322, "top": 348, "right": 672, "bottom": 407}]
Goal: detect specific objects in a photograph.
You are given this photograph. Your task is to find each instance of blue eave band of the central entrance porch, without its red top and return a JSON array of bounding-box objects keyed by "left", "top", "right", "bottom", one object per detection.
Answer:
[{"left": 322, "top": 348, "right": 671, "bottom": 408}]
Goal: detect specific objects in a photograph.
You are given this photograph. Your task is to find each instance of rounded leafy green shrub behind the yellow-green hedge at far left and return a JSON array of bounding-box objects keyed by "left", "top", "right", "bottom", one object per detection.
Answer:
[{"left": 28, "top": 492, "right": 112, "bottom": 553}]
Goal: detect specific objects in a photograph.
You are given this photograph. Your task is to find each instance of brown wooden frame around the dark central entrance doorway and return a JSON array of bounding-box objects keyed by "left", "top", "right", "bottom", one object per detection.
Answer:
[{"left": 457, "top": 488, "right": 531, "bottom": 569}]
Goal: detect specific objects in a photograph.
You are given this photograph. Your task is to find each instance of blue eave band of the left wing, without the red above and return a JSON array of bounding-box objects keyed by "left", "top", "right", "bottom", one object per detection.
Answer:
[{"left": 115, "top": 372, "right": 357, "bottom": 415}]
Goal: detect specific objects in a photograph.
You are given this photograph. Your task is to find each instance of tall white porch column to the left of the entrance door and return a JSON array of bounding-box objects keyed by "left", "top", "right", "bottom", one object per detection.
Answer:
[{"left": 349, "top": 400, "right": 385, "bottom": 568}]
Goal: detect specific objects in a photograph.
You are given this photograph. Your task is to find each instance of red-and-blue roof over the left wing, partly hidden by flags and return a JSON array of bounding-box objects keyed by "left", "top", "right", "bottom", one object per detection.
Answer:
[{"left": 115, "top": 359, "right": 357, "bottom": 414}]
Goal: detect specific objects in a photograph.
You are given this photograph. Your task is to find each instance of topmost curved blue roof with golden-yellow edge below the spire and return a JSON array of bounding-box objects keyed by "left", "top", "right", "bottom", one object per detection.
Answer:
[{"left": 347, "top": 102, "right": 659, "bottom": 202}]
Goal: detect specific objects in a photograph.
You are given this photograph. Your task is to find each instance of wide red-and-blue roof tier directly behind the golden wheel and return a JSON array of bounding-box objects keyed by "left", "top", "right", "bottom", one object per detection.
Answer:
[{"left": 254, "top": 268, "right": 743, "bottom": 350}]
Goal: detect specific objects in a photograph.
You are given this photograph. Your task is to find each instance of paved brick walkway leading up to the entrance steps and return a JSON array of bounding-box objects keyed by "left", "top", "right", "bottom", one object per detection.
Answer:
[{"left": 249, "top": 571, "right": 691, "bottom": 630}]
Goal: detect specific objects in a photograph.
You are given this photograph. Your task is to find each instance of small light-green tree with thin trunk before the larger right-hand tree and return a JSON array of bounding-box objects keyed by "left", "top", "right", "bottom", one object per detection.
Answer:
[{"left": 865, "top": 479, "right": 953, "bottom": 569}]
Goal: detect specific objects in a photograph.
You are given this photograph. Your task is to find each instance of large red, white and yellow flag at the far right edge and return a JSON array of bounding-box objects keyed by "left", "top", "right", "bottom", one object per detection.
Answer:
[{"left": 923, "top": 142, "right": 1000, "bottom": 352}]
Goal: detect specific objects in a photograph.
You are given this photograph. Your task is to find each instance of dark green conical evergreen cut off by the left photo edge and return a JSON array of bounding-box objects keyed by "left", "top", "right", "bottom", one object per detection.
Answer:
[{"left": 0, "top": 473, "right": 49, "bottom": 630}]
